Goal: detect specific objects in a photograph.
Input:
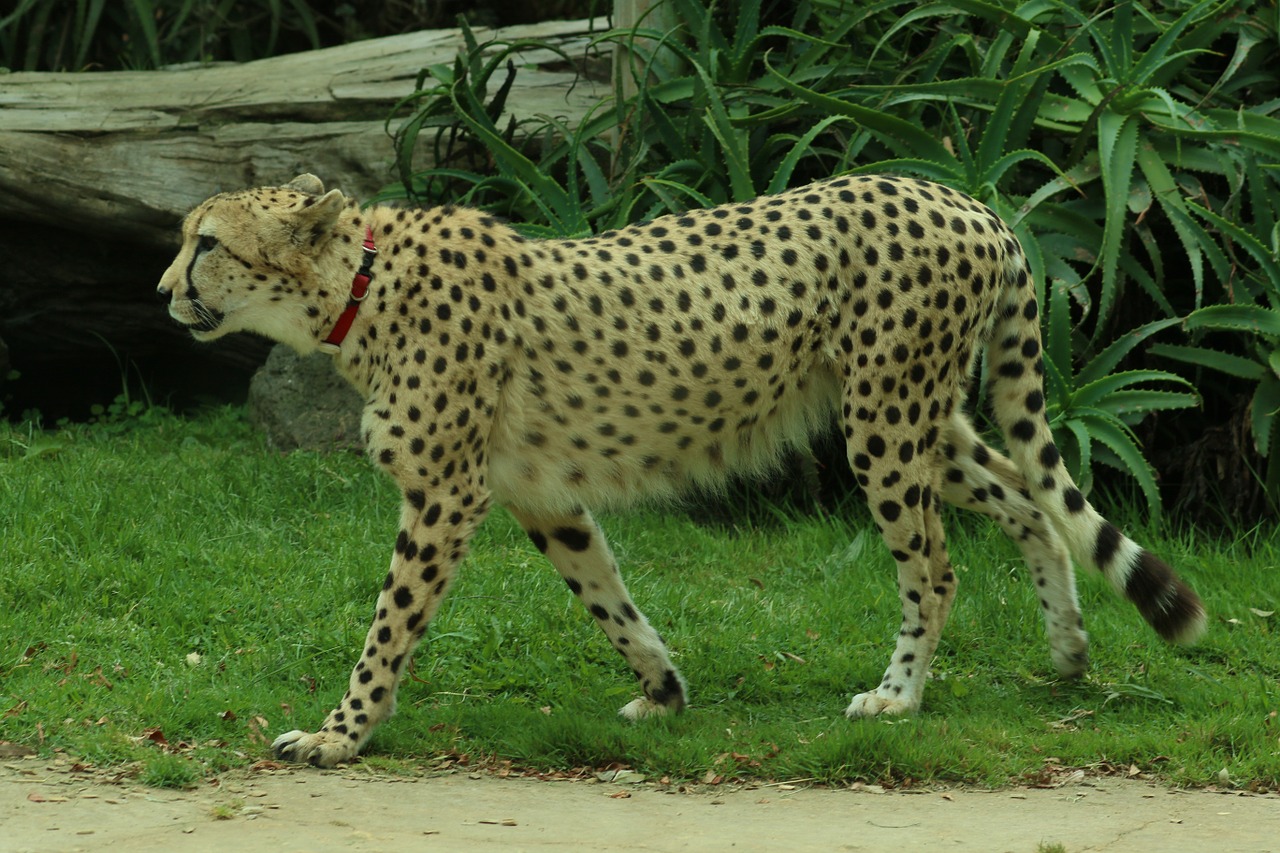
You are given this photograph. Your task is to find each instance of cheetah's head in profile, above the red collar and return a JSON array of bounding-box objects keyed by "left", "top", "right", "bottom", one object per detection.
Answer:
[{"left": 157, "top": 174, "right": 358, "bottom": 352}]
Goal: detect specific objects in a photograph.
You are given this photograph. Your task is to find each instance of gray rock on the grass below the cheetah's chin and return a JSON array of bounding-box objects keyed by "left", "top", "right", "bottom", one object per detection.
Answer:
[{"left": 248, "top": 346, "right": 364, "bottom": 451}]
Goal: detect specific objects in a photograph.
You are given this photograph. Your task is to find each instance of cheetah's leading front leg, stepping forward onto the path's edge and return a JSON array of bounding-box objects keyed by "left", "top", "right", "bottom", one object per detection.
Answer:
[{"left": 271, "top": 489, "right": 488, "bottom": 767}]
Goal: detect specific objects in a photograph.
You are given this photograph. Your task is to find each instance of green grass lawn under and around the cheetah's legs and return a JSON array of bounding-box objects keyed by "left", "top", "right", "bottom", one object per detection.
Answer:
[{"left": 0, "top": 410, "right": 1280, "bottom": 788}]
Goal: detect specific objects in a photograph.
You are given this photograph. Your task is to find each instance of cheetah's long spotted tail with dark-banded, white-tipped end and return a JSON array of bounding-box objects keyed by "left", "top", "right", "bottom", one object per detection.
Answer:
[{"left": 987, "top": 251, "right": 1206, "bottom": 643}]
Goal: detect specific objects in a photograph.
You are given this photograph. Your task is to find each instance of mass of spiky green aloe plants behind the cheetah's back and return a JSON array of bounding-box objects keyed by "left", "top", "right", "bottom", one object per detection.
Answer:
[{"left": 383, "top": 0, "right": 1280, "bottom": 514}]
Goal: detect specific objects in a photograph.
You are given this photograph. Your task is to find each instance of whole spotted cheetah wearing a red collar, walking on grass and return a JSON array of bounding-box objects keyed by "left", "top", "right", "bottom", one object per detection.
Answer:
[{"left": 159, "top": 174, "right": 1206, "bottom": 767}]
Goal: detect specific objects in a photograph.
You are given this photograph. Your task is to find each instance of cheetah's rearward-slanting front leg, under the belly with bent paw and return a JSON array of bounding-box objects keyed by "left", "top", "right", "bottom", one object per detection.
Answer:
[{"left": 508, "top": 507, "right": 685, "bottom": 720}]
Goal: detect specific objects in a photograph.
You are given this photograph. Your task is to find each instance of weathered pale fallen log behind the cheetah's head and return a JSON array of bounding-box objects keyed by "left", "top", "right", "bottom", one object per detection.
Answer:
[{"left": 0, "top": 19, "right": 604, "bottom": 245}]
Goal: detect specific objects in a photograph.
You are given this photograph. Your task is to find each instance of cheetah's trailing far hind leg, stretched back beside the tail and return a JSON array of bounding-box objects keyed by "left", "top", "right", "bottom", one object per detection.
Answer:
[{"left": 942, "top": 416, "right": 1089, "bottom": 678}]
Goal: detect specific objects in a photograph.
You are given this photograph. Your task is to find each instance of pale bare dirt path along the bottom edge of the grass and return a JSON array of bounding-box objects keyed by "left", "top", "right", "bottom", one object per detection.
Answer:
[{"left": 0, "top": 758, "right": 1280, "bottom": 853}]
